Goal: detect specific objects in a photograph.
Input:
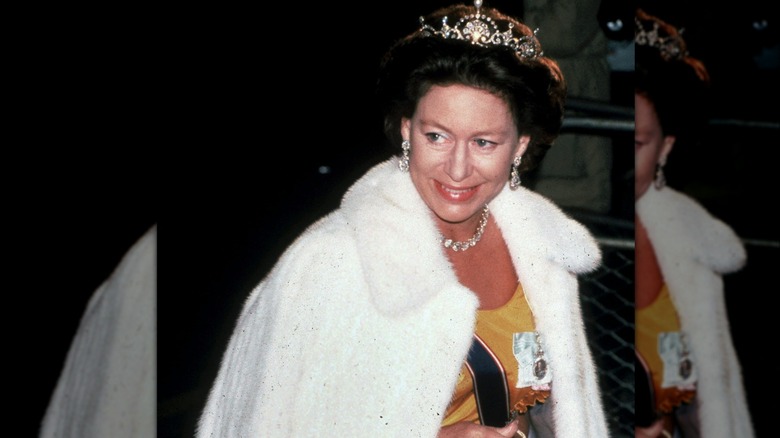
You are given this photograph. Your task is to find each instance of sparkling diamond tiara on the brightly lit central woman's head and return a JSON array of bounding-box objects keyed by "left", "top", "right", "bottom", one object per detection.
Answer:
[{"left": 420, "top": 0, "right": 544, "bottom": 60}]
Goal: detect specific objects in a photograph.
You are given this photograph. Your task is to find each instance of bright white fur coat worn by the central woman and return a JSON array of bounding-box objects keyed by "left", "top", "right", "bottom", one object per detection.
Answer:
[{"left": 197, "top": 160, "right": 608, "bottom": 438}]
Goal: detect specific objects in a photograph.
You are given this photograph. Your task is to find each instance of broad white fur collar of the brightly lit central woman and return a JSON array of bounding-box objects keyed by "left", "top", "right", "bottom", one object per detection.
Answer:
[{"left": 341, "top": 158, "right": 601, "bottom": 314}]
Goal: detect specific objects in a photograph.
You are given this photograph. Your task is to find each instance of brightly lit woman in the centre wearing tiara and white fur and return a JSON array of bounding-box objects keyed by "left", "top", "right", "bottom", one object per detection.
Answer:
[{"left": 197, "top": 2, "right": 608, "bottom": 438}]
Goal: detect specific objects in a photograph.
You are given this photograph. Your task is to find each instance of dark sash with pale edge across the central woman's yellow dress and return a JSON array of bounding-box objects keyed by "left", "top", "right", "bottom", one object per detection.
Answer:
[{"left": 466, "top": 334, "right": 509, "bottom": 427}]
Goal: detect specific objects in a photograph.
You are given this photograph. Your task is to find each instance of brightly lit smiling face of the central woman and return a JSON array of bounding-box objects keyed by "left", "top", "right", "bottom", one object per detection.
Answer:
[{"left": 401, "top": 85, "right": 529, "bottom": 223}]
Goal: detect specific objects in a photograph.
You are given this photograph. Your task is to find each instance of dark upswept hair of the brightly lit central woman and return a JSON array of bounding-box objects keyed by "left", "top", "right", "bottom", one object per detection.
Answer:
[{"left": 376, "top": 5, "right": 566, "bottom": 172}]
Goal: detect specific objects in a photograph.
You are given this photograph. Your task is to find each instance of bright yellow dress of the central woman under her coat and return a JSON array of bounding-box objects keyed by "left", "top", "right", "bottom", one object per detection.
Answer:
[{"left": 442, "top": 284, "right": 550, "bottom": 426}]
